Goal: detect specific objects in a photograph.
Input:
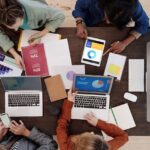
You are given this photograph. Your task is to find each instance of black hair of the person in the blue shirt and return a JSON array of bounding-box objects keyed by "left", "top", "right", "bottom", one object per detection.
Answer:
[{"left": 98, "top": 0, "right": 137, "bottom": 29}]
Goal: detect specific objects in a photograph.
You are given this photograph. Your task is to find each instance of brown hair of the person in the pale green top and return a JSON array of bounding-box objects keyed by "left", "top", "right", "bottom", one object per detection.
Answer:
[{"left": 0, "top": 0, "right": 24, "bottom": 26}]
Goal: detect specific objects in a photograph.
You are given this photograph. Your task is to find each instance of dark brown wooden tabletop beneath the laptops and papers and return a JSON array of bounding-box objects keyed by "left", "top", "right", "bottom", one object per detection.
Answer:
[{"left": 0, "top": 27, "right": 150, "bottom": 136}]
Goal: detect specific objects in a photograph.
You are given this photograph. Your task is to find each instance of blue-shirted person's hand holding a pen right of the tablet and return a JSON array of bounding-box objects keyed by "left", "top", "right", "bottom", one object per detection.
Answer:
[{"left": 111, "top": 41, "right": 127, "bottom": 53}]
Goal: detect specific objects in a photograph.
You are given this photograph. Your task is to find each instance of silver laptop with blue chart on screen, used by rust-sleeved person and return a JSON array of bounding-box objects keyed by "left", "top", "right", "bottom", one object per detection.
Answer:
[{"left": 71, "top": 74, "right": 113, "bottom": 121}]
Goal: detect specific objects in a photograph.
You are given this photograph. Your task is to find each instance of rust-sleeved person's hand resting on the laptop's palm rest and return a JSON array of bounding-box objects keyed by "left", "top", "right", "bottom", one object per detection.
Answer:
[{"left": 84, "top": 112, "right": 98, "bottom": 127}]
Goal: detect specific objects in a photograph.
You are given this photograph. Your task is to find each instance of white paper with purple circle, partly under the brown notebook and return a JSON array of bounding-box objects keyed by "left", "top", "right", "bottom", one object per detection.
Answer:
[{"left": 51, "top": 65, "right": 85, "bottom": 89}]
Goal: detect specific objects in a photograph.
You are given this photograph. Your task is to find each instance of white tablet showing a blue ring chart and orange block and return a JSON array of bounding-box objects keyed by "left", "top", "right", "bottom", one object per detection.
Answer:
[{"left": 81, "top": 37, "right": 105, "bottom": 66}]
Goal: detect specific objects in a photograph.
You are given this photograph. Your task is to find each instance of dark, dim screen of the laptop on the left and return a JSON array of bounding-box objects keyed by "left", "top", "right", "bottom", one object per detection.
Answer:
[{"left": 1, "top": 77, "right": 42, "bottom": 91}]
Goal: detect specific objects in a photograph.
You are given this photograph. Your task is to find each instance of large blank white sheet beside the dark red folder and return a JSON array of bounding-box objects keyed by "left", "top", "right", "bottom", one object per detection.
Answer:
[{"left": 44, "top": 39, "right": 72, "bottom": 75}]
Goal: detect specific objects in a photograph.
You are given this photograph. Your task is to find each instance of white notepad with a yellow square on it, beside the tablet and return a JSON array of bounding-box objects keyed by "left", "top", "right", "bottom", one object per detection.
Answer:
[{"left": 104, "top": 53, "right": 126, "bottom": 80}]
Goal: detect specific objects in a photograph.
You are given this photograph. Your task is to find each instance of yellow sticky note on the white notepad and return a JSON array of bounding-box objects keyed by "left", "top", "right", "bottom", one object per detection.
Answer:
[{"left": 108, "top": 64, "right": 121, "bottom": 76}]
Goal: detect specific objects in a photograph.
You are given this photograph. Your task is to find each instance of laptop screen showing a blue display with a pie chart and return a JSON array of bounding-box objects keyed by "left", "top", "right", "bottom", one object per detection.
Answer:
[{"left": 73, "top": 75, "right": 113, "bottom": 94}]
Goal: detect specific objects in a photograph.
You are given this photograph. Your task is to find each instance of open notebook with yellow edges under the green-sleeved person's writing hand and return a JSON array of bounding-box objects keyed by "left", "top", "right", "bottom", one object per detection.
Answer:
[{"left": 18, "top": 30, "right": 61, "bottom": 51}]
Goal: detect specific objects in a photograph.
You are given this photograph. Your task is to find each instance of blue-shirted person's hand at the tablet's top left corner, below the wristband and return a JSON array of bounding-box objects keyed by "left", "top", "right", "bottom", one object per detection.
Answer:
[{"left": 77, "top": 24, "right": 88, "bottom": 39}]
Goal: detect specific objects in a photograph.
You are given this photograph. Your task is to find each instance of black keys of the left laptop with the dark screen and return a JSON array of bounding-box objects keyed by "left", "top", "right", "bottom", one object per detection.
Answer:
[{"left": 8, "top": 94, "right": 40, "bottom": 107}]
